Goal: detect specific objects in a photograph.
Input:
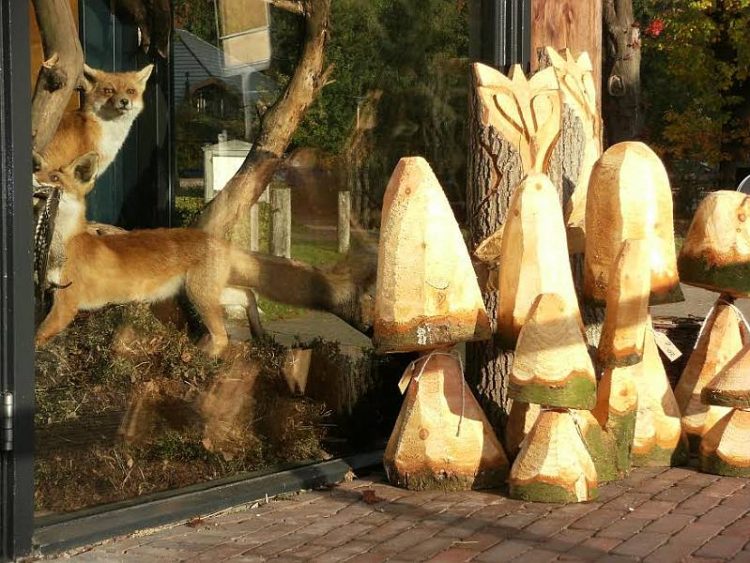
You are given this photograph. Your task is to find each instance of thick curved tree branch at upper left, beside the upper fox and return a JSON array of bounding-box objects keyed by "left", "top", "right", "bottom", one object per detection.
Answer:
[{"left": 31, "top": 0, "right": 83, "bottom": 151}]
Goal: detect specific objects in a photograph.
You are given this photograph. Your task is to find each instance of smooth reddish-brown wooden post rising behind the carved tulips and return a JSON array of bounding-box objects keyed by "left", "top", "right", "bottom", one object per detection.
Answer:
[{"left": 531, "top": 0, "right": 602, "bottom": 107}]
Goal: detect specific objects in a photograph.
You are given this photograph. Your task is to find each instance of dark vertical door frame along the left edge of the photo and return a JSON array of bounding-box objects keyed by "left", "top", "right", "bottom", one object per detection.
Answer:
[{"left": 0, "top": 2, "right": 34, "bottom": 560}]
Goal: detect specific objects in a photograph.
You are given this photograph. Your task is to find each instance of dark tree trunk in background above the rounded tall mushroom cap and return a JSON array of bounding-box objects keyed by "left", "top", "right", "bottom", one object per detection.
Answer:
[{"left": 602, "top": 0, "right": 643, "bottom": 145}]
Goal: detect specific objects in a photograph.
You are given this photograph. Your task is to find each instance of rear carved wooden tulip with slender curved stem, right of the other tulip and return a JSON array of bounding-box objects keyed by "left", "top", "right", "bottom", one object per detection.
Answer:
[{"left": 545, "top": 46, "right": 602, "bottom": 254}]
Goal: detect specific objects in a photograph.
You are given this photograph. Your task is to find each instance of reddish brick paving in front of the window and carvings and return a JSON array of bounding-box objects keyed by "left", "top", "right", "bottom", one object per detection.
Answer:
[{"left": 50, "top": 468, "right": 750, "bottom": 563}]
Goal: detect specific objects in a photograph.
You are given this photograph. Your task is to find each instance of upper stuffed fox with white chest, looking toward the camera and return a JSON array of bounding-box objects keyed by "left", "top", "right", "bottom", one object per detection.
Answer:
[{"left": 36, "top": 65, "right": 154, "bottom": 174}]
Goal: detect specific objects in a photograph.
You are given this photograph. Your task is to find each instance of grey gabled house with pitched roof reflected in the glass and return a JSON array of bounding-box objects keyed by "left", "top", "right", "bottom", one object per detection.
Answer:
[{"left": 173, "top": 29, "right": 276, "bottom": 113}]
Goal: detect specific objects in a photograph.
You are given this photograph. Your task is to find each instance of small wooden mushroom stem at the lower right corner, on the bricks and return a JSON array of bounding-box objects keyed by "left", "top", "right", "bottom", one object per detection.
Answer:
[{"left": 699, "top": 410, "right": 750, "bottom": 477}]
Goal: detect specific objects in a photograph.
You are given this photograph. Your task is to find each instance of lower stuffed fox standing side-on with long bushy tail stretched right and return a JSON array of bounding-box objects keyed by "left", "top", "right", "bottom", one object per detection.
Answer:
[{"left": 34, "top": 153, "right": 375, "bottom": 355}]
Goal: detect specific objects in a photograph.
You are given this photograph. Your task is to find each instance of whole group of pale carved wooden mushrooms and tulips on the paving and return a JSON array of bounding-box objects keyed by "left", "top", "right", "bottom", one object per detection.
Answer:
[{"left": 374, "top": 48, "right": 750, "bottom": 502}]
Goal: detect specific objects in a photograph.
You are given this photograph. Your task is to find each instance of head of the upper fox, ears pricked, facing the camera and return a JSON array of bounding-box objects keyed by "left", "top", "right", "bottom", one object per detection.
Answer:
[{"left": 83, "top": 65, "right": 154, "bottom": 120}]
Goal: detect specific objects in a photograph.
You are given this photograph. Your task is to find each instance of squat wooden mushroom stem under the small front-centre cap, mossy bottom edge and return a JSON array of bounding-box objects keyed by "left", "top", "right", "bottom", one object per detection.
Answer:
[{"left": 508, "top": 410, "right": 598, "bottom": 503}]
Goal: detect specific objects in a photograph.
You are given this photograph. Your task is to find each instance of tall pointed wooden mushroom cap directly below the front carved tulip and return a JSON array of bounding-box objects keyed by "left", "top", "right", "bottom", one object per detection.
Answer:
[{"left": 497, "top": 174, "right": 583, "bottom": 347}]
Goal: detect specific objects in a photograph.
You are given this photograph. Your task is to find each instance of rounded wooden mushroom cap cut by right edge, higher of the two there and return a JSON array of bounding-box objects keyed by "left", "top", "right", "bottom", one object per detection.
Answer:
[{"left": 678, "top": 190, "right": 750, "bottom": 297}]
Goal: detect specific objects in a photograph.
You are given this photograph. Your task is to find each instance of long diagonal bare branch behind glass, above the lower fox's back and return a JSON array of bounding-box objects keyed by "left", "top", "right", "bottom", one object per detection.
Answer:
[{"left": 196, "top": 0, "right": 332, "bottom": 237}]
